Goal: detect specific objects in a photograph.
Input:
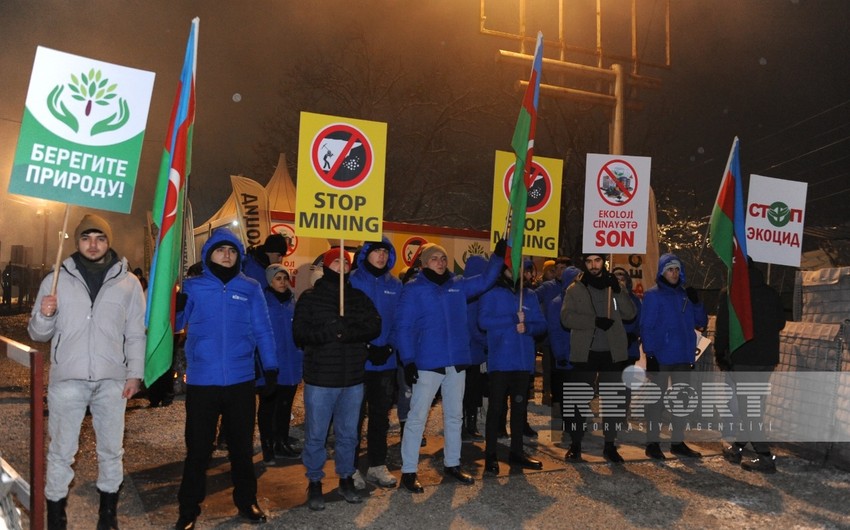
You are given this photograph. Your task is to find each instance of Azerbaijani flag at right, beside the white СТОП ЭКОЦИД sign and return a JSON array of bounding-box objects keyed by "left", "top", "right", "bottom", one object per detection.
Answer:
[{"left": 709, "top": 137, "right": 753, "bottom": 352}]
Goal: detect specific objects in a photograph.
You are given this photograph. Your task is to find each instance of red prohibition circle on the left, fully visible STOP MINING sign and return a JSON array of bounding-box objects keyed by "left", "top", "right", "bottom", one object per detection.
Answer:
[{"left": 310, "top": 123, "right": 374, "bottom": 189}]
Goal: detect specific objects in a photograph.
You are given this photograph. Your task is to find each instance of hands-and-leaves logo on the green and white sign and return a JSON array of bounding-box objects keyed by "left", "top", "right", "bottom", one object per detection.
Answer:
[{"left": 47, "top": 68, "right": 130, "bottom": 136}]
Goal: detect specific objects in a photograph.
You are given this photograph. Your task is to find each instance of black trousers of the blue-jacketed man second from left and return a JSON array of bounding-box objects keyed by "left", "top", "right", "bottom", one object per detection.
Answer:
[{"left": 177, "top": 381, "right": 257, "bottom": 516}]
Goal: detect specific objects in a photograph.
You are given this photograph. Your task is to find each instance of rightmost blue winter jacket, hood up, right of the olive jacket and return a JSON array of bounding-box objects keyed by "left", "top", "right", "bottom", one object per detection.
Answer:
[{"left": 640, "top": 254, "right": 708, "bottom": 365}]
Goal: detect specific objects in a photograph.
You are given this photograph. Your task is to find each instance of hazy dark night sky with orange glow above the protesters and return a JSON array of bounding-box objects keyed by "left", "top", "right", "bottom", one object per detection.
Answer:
[{"left": 0, "top": 0, "right": 850, "bottom": 262}]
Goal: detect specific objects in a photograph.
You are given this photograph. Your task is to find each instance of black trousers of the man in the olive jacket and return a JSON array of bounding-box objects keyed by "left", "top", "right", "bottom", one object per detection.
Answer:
[{"left": 562, "top": 350, "right": 626, "bottom": 444}]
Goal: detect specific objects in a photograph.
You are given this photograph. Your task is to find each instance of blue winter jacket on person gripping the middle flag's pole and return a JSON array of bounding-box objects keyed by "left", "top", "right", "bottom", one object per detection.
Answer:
[{"left": 478, "top": 276, "right": 546, "bottom": 373}]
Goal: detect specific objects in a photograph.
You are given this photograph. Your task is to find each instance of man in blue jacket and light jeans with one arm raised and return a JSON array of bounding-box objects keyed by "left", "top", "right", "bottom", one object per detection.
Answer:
[{"left": 396, "top": 240, "right": 507, "bottom": 493}]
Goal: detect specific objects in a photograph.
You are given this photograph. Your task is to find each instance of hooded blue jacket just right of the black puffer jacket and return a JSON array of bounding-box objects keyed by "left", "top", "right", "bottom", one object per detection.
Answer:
[{"left": 349, "top": 236, "right": 402, "bottom": 372}]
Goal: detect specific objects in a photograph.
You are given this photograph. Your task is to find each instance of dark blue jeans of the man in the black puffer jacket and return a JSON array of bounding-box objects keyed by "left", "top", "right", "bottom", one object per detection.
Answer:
[{"left": 301, "top": 383, "right": 363, "bottom": 482}]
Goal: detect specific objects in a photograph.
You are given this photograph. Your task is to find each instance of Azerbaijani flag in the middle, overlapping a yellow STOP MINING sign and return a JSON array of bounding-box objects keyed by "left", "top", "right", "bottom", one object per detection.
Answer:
[{"left": 505, "top": 31, "right": 543, "bottom": 281}]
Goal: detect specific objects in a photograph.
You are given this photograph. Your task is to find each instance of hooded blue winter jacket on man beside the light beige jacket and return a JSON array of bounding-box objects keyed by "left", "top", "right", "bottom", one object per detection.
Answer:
[{"left": 177, "top": 228, "right": 278, "bottom": 386}]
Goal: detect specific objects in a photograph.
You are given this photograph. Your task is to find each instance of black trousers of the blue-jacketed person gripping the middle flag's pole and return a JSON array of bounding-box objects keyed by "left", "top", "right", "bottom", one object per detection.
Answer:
[{"left": 484, "top": 371, "right": 531, "bottom": 455}]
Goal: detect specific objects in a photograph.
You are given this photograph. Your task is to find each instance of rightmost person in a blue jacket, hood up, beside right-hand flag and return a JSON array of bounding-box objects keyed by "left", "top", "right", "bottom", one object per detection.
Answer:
[{"left": 640, "top": 254, "right": 708, "bottom": 460}]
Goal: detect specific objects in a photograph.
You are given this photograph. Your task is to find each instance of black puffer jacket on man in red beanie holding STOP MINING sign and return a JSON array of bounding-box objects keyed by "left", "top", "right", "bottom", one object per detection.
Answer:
[{"left": 292, "top": 268, "right": 381, "bottom": 388}]
